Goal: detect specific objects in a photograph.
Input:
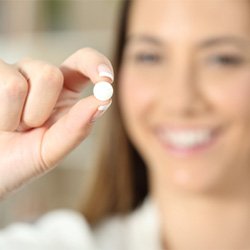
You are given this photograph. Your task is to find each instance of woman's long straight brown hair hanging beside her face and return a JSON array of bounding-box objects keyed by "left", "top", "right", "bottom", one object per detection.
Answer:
[{"left": 82, "top": 1, "right": 148, "bottom": 225}]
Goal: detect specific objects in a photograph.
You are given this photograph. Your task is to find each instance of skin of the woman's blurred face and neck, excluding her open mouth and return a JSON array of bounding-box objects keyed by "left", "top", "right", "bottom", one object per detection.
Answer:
[{"left": 119, "top": 0, "right": 250, "bottom": 250}]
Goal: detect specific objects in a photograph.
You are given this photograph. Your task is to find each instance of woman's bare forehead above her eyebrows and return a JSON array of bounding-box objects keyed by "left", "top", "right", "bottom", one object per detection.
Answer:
[{"left": 128, "top": 0, "right": 250, "bottom": 41}]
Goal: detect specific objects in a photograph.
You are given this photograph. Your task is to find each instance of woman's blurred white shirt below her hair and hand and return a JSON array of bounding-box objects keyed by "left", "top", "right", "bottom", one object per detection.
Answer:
[{"left": 0, "top": 199, "right": 161, "bottom": 250}]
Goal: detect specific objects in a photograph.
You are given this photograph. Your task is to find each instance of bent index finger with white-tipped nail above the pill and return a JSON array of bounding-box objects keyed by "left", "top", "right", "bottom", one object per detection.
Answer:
[{"left": 60, "top": 48, "right": 114, "bottom": 92}]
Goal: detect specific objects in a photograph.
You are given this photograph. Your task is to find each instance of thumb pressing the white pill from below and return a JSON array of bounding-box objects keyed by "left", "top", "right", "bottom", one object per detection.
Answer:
[{"left": 41, "top": 96, "right": 110, "bottom": 168}]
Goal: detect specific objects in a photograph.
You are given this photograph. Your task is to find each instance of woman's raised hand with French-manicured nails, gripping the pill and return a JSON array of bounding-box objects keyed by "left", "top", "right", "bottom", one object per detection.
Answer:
[{"left": 0, "top": 48, "right": 113, "bottom": 196}]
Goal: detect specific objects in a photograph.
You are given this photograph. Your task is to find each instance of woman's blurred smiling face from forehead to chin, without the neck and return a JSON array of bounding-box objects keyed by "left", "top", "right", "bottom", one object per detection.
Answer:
[{"left": 119, "top": 0, "right": 250, "bottom": 191}]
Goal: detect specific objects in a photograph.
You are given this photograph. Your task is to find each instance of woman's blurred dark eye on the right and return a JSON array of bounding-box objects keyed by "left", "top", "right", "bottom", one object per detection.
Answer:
[{"left": 208, "top": 54, "right": 244, "bottom": 67}]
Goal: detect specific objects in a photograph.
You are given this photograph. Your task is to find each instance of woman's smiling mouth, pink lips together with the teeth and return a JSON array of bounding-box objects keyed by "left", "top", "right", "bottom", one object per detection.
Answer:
[{"left": 157, "top": 128, "right": 218, "bottom": 152}]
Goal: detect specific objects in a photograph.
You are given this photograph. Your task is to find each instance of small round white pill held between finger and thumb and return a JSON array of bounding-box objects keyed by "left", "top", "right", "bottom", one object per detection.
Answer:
[{"left": 93, "top": 81, "right": 113, "bottom": 101}]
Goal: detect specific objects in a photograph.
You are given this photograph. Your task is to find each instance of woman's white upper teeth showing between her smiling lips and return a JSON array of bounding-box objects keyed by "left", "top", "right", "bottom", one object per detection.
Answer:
[{"left": 162, "top": 130, "right": 212, "bottom": 148}]
